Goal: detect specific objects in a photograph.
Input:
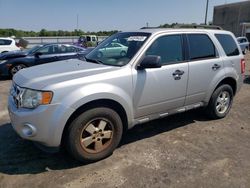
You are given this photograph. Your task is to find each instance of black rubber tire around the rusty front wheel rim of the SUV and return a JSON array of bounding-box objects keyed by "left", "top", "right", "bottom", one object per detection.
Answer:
[{"left": 68, "top": 108, "right": 123, "bottom": 162}]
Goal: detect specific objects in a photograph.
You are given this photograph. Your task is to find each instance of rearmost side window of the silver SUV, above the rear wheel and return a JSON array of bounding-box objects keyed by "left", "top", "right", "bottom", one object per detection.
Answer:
[{"left": 215, "top": 34, "right": 240, "bottom": 56}]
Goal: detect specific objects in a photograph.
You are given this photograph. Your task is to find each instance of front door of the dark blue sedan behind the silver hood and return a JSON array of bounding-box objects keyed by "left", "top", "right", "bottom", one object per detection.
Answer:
[{"left": 34, "top": 44, "right": 59, "bottom": 64}]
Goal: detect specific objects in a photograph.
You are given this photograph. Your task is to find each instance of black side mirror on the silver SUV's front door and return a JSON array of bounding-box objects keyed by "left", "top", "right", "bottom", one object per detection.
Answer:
[{"left": 137, "top": 55, "right": 161, "bottom": 70}]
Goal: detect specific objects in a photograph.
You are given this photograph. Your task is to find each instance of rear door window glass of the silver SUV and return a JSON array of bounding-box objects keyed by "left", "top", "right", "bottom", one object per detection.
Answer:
[{"left": 188, "top": 34, "right": 216, "bottom": 60}]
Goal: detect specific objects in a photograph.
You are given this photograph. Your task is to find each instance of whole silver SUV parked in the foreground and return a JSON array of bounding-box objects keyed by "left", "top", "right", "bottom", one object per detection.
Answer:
[{"left": 9, "top": 29, "right": 245, "bottom": 162}]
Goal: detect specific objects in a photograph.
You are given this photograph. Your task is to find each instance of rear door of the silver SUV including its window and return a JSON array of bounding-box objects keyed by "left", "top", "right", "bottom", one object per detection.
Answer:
[{"left": 185, "top": 33, "right": 223, "bottom": 105}]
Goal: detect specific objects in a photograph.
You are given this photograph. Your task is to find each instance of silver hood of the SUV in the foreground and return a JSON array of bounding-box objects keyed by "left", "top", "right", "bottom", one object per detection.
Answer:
[{"left": 13, "top": 59, "right": 119, "bottom": 90}]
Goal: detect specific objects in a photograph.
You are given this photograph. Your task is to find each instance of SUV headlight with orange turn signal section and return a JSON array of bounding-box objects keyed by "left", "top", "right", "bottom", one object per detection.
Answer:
[{"left": 20, "top": 88, "right": 53, "bottom": 108}]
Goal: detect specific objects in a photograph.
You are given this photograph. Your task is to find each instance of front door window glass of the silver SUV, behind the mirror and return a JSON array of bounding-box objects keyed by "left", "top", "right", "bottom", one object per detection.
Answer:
[{"left": 146, "top": 35, "right": 183, "bottom": 64}]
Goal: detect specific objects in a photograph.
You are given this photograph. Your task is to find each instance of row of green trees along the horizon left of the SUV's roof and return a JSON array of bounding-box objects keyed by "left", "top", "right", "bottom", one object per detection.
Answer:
[{"left": 0, "top": 29, "right": 118, "bottom": 38}]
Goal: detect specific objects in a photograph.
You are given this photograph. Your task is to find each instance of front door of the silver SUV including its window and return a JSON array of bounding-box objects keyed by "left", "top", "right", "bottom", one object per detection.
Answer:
[{"left": 133, "top": 35, "right": 188, "bottom": 118}]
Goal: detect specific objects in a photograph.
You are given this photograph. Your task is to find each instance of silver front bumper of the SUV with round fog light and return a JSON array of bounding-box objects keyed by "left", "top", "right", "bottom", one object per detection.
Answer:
[{"left": 8, "top": 96, "right": 74, "bottom": 148}]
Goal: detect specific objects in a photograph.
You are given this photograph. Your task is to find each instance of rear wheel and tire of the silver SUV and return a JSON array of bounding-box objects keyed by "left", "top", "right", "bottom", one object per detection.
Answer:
[{"left": 206, "top": 84, "right": 234, "bottom": 119}]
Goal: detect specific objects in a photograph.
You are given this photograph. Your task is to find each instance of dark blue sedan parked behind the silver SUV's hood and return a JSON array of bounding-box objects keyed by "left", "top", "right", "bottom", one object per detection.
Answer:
[{"left": 0, "top": 44, "right": 92, "bottom": 76}]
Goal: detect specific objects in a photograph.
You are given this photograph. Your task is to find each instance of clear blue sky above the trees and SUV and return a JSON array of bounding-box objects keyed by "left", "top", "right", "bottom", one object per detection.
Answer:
[{"left": 0, "top": 0, "right": 247, "bottom": 31}]
